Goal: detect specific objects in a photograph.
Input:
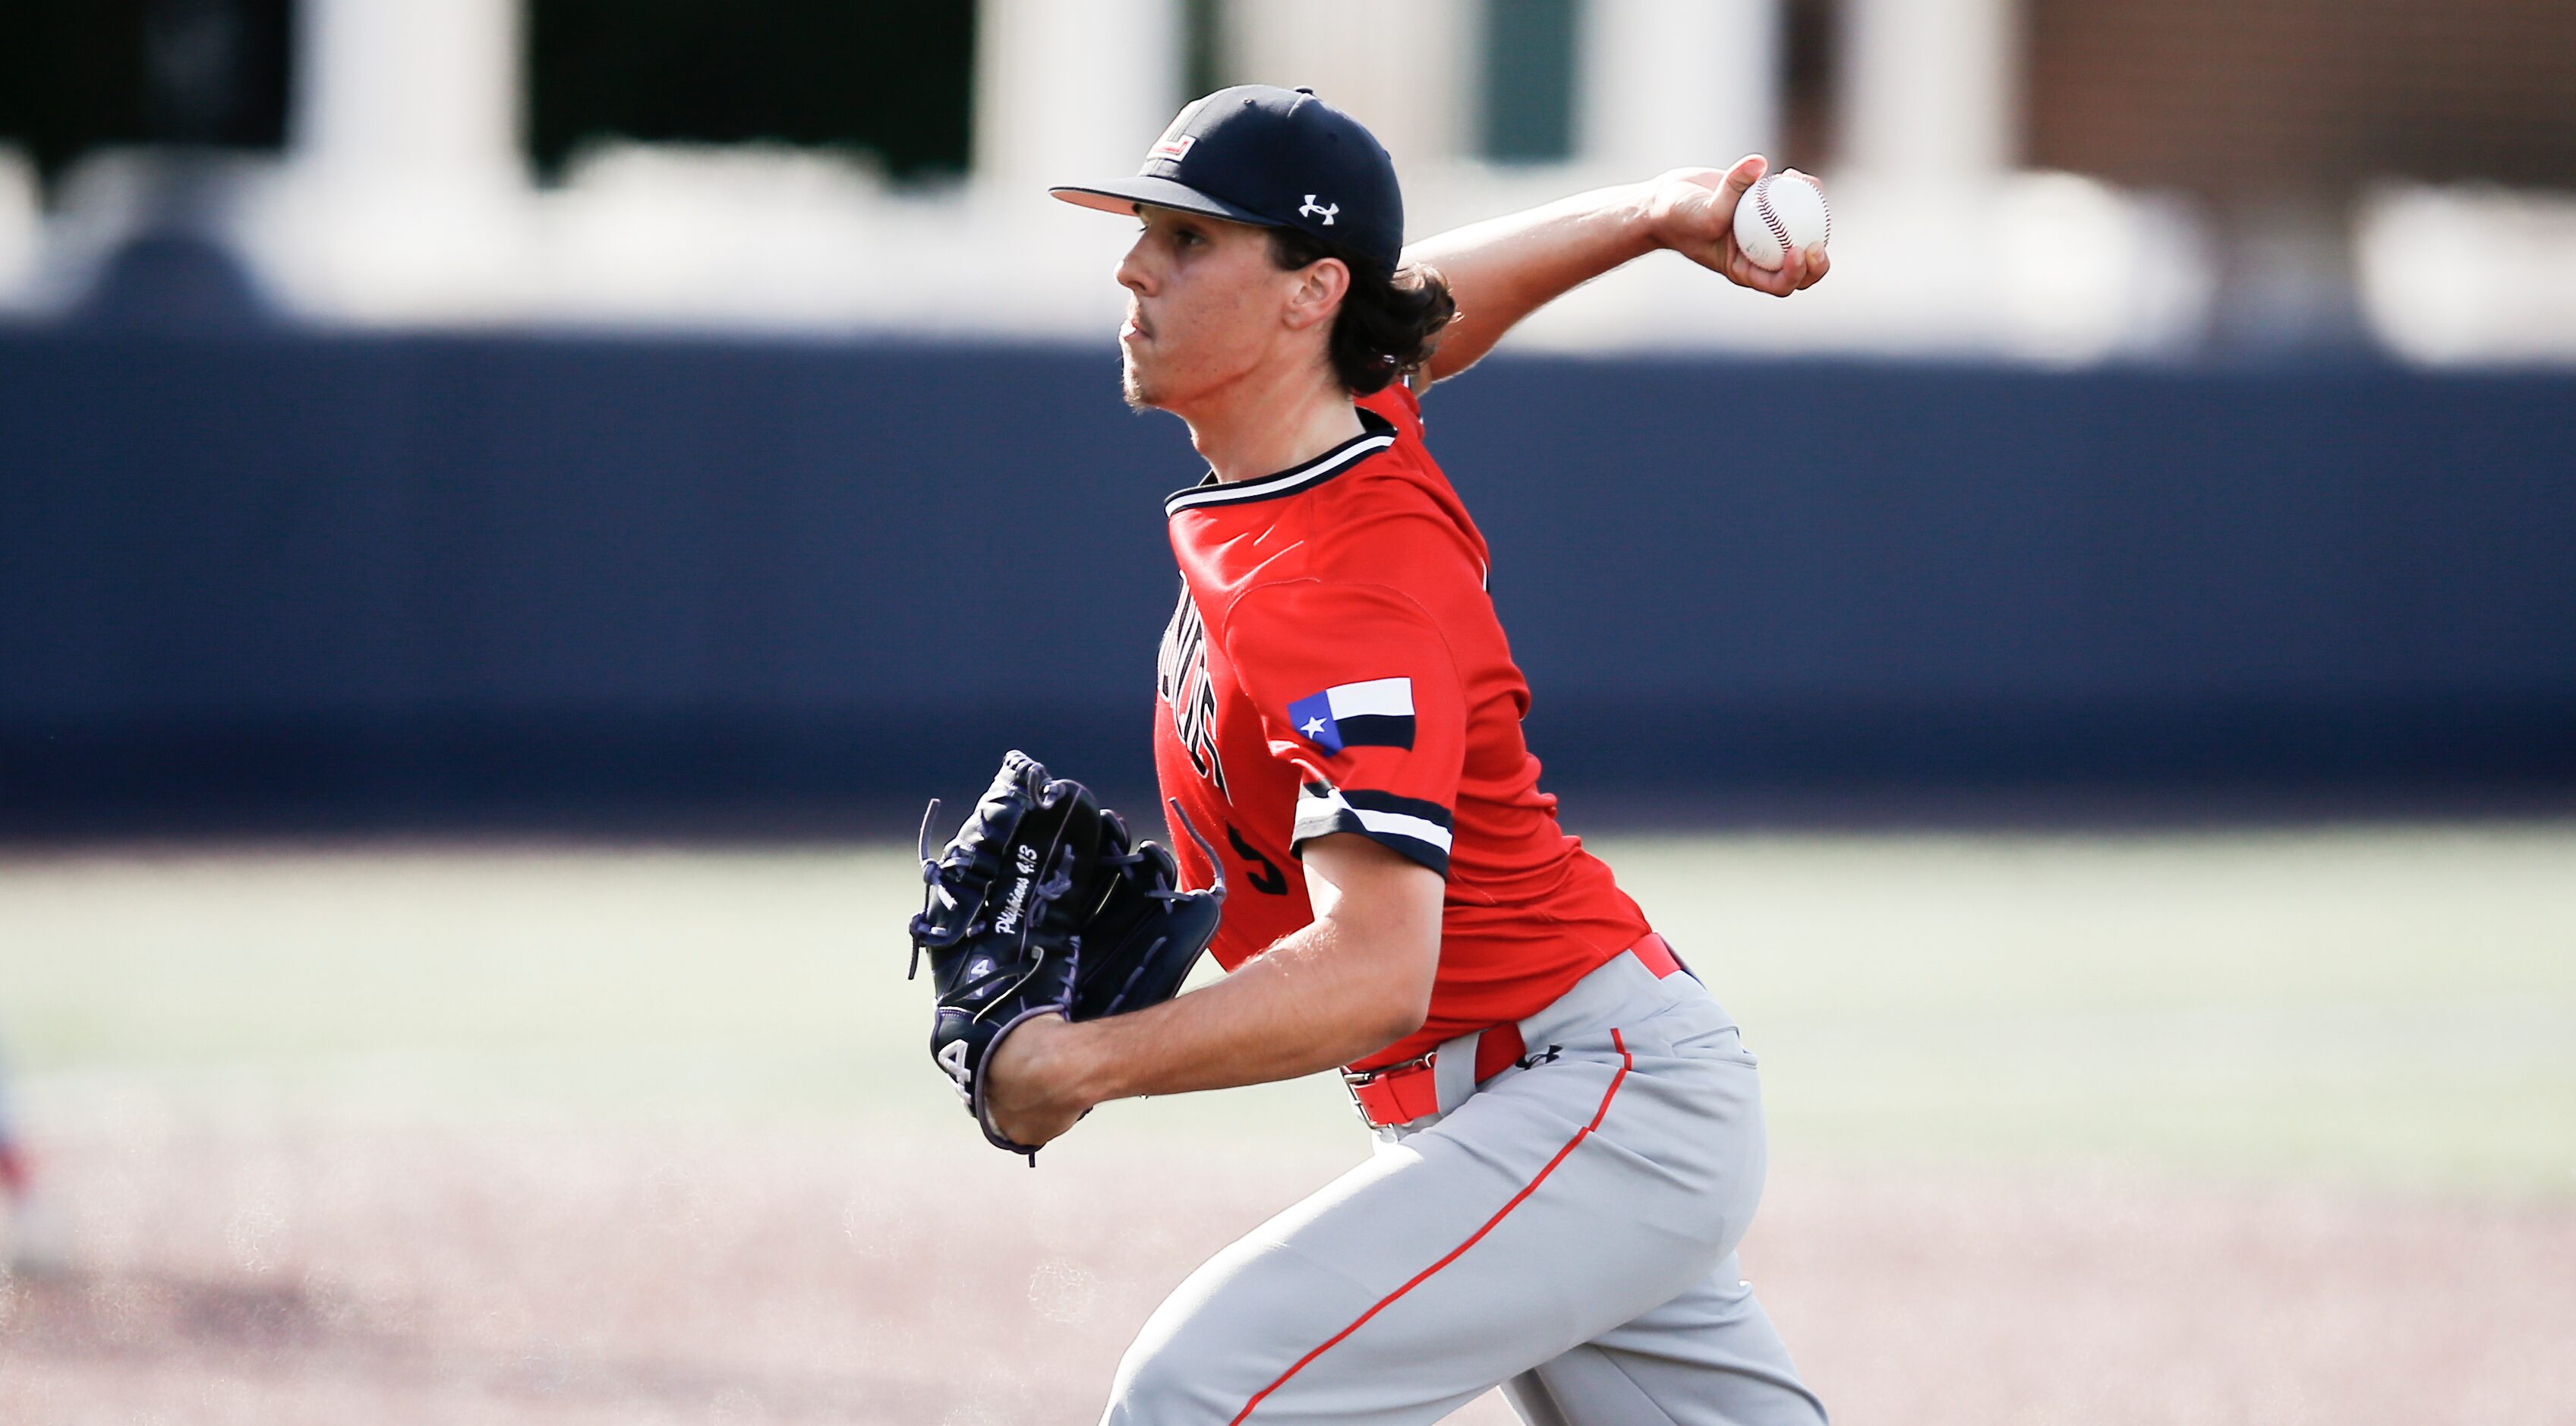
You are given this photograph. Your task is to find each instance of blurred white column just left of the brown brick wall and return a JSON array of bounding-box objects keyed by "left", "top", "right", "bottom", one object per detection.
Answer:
[{"left": 1840, "top": 0, "right": 2023, "bottom": 181}]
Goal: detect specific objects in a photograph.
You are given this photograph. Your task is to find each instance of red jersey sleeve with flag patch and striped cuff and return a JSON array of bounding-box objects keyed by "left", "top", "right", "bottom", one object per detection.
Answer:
[{"left": 1226, "top": 580, "right": 1466, "bottom": 877}]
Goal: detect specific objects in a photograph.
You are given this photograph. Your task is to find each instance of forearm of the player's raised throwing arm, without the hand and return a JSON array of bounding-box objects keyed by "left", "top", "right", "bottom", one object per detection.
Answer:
[{"left": 1404, "top": 183, "right": 1657, "bottom": 382}]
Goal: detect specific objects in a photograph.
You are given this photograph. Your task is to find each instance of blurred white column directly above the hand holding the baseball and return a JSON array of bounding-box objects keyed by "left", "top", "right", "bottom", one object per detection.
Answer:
[{"left": 1574, "top": 0, "right": 1780, "bottom": 178}]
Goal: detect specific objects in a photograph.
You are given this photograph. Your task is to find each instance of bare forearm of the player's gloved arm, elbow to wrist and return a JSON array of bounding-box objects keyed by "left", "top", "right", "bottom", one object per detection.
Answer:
[{"left": 1074, "top": 920, "right": 1427, "bottom": 1101}]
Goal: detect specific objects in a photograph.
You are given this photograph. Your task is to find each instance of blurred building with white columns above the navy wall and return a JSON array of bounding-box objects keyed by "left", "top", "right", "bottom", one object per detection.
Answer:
[{"left": 0, "top": 0, "right": 2576, "bottom": 364}]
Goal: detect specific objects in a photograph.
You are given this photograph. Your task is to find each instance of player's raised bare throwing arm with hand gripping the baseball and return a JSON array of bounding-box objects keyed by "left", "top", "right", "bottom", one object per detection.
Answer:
[{"left": 1404, "top": 155, "right": 1831, "bottom": 384}]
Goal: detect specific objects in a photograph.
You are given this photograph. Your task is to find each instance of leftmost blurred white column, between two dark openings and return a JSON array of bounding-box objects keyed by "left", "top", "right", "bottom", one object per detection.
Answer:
[{"left": 294, "top": 0, "right": 523, "bottom": 186}]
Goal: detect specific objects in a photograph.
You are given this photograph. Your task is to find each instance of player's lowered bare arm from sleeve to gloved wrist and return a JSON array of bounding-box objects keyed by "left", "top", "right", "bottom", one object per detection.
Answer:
[{"left": 987, "top": 833, "right": 1442, "bottom": 1145}]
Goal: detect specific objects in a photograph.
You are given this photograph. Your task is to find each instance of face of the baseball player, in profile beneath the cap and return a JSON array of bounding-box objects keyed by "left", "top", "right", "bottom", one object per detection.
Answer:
[{"left": 1118, "top": 207, "right": 1304, "bottom": 418}]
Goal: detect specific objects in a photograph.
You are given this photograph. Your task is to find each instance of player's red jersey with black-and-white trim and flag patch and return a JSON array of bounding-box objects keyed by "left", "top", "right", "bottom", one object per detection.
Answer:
[{"left": 1154, "top": 386, "right": 1646, "bottom": 1070}]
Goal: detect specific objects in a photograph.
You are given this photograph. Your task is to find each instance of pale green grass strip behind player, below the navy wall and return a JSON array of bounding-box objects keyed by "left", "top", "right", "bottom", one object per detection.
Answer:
[{"left": 0, "top": 825, "right": 2576, "bottom": 1199}]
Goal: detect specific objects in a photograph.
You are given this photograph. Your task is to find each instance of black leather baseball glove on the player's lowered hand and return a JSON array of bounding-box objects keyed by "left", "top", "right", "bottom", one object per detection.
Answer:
[{"left": 912, "top": 753, "right": 1226, "bottom": 1163}]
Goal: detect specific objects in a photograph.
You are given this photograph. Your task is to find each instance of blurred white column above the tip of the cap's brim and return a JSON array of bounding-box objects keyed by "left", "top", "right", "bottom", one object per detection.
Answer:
[{"left": 971, "top": 0, "right": 1182, "bottom": 188}]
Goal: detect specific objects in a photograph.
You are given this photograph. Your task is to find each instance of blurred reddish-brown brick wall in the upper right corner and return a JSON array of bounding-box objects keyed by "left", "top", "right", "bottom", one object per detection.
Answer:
[{"left": 2025, "top": 0, "right": 2576, "bottom": 198}]
